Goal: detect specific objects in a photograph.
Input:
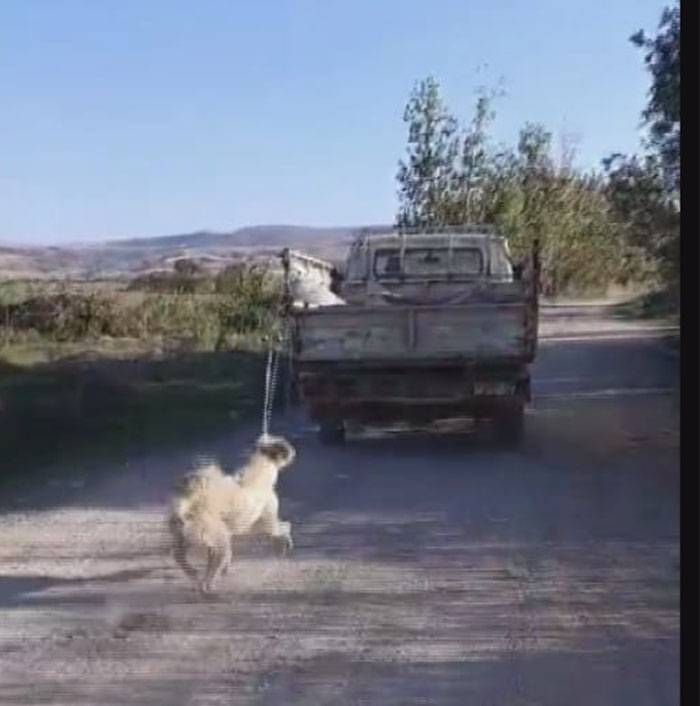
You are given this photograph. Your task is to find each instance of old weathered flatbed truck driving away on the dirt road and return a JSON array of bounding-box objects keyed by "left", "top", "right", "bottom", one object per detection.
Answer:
[{"left": 282, "top": 225, "right": 539, "bottom": 443}]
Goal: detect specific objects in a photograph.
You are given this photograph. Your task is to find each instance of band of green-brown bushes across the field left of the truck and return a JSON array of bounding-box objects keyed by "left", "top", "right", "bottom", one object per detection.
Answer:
[{"left": 0, "top": 266, "right": 281, "bottom": 350}]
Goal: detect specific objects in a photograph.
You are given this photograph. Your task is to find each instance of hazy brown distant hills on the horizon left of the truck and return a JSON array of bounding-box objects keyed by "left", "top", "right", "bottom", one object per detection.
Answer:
[{"left": 0, "top": 225, "right": 378, "bottom": 279}]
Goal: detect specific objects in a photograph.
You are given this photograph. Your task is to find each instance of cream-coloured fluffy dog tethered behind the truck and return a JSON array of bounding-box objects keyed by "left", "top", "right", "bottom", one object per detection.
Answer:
[{"left": 168, "top": 436, "right": 296, "bottom": 594}]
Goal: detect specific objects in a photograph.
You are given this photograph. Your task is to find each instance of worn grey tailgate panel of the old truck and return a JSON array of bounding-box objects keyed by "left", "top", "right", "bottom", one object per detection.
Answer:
[{"left": 295, "top": 302, "right": 529, "bottom": 363}]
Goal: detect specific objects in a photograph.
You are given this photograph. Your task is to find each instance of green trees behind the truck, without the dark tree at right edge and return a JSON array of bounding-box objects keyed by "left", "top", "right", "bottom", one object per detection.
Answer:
[{"left": 398, "top": 79, "right": 634, "bottom": 295}]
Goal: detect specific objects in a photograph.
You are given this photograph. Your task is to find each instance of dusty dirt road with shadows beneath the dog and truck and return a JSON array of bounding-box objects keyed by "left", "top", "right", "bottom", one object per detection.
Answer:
[{"left": 0, "top": 311, "right": 679, "bottom": 706}]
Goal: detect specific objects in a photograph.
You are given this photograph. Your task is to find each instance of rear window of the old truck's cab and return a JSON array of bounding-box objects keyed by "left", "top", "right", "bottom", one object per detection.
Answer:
[{"left": 374, "top": 248, "right": 484, "bottom": 279}]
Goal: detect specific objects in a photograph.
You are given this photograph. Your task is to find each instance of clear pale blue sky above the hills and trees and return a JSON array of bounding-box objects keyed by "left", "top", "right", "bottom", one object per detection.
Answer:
[{"left": 0, "top": 0, "right": 663, "bottom": 243}]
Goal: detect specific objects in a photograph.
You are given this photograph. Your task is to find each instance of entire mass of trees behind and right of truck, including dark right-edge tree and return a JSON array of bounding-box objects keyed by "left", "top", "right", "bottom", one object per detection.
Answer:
[{"left": 397, "top": 2, "right": 680, "bottom": 295}]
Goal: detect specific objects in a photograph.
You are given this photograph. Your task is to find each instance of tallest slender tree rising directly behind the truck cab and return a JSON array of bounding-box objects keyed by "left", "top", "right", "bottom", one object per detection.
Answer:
[{"left": 397, "top": 77, "right": 458, "bottom": 227}]
